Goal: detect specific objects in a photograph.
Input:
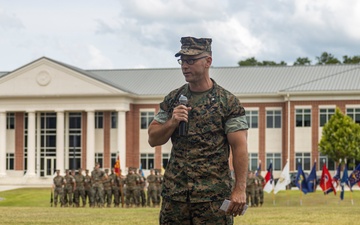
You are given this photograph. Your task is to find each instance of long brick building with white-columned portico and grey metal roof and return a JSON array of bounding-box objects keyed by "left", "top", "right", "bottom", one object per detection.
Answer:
[{"left": 0, "top": 57, "right": 360, "bottom": 184}]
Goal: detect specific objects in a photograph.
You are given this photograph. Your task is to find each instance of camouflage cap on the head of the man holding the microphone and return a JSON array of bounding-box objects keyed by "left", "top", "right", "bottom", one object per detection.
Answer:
[{"left": 175, "top": 37, "right": 212, "bottom": 57}]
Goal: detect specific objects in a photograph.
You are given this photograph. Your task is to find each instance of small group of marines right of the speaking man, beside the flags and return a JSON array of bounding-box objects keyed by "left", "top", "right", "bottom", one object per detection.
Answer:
[{"left": 246, "top": 171, "right": 265, "bottom": 207}]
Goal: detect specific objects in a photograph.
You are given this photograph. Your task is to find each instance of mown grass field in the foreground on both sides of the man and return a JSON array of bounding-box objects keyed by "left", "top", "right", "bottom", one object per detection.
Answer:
[{"left": 0, "top": 188, "right": 360, "bottom": 225}]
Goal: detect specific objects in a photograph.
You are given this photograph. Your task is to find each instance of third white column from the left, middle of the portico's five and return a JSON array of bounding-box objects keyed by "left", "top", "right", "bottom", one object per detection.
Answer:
[{"left": 56, "top": 111, "right": 65, "bottom": 173}]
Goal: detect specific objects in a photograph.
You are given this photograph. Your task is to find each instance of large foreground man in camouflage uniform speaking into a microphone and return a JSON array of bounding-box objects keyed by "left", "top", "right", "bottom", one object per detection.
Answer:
[{"left": 149, "top": 37, "right": 248, "bottom": 224}]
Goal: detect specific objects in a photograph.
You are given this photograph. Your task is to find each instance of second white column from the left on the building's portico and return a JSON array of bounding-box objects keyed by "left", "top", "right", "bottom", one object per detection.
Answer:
[{"left": 26, "top": 112, "right": 36, "bottom": 177}]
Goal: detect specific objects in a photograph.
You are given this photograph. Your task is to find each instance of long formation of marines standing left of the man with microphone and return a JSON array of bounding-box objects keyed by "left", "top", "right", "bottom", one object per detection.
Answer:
[{"left": 53, "top": 163, "right": 163, "bottom": 208}]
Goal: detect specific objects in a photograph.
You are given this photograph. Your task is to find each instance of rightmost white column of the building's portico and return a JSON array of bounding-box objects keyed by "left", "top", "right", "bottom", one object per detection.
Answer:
[{"left": 117, "top": 111, "right": 126, "bottom": 172}]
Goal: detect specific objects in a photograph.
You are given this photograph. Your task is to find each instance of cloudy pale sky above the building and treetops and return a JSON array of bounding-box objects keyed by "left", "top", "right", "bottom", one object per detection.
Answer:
[{"left": 0, "top": 0, "right": 360, "bottom": 72}]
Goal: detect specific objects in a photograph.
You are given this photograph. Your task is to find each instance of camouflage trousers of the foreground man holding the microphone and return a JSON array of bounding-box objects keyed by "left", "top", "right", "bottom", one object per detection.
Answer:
[{"left": 159, "top": 198, "right": 234, "bottom": 225}]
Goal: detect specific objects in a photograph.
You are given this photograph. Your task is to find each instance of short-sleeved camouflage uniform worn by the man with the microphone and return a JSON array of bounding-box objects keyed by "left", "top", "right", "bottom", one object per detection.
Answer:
[{"left": 154, "top": 80, "right": 248, "bottom": 224}]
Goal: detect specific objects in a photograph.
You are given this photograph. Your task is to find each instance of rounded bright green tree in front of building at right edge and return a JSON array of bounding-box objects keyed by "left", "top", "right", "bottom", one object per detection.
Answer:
[{"left": 319, "top": 108, "right": 360, "bottom": 162}]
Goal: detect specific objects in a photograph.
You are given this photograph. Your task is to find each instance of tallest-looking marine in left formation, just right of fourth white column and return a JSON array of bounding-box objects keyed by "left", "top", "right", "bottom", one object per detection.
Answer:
[{"left": 91, "top": 163, "right": 107, "bottom": 207}]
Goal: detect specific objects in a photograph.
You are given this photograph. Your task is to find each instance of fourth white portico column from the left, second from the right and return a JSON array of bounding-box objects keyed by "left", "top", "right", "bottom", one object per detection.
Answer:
[{"left": 86, "top": 111, "right": 94, "bottom": 171}]
